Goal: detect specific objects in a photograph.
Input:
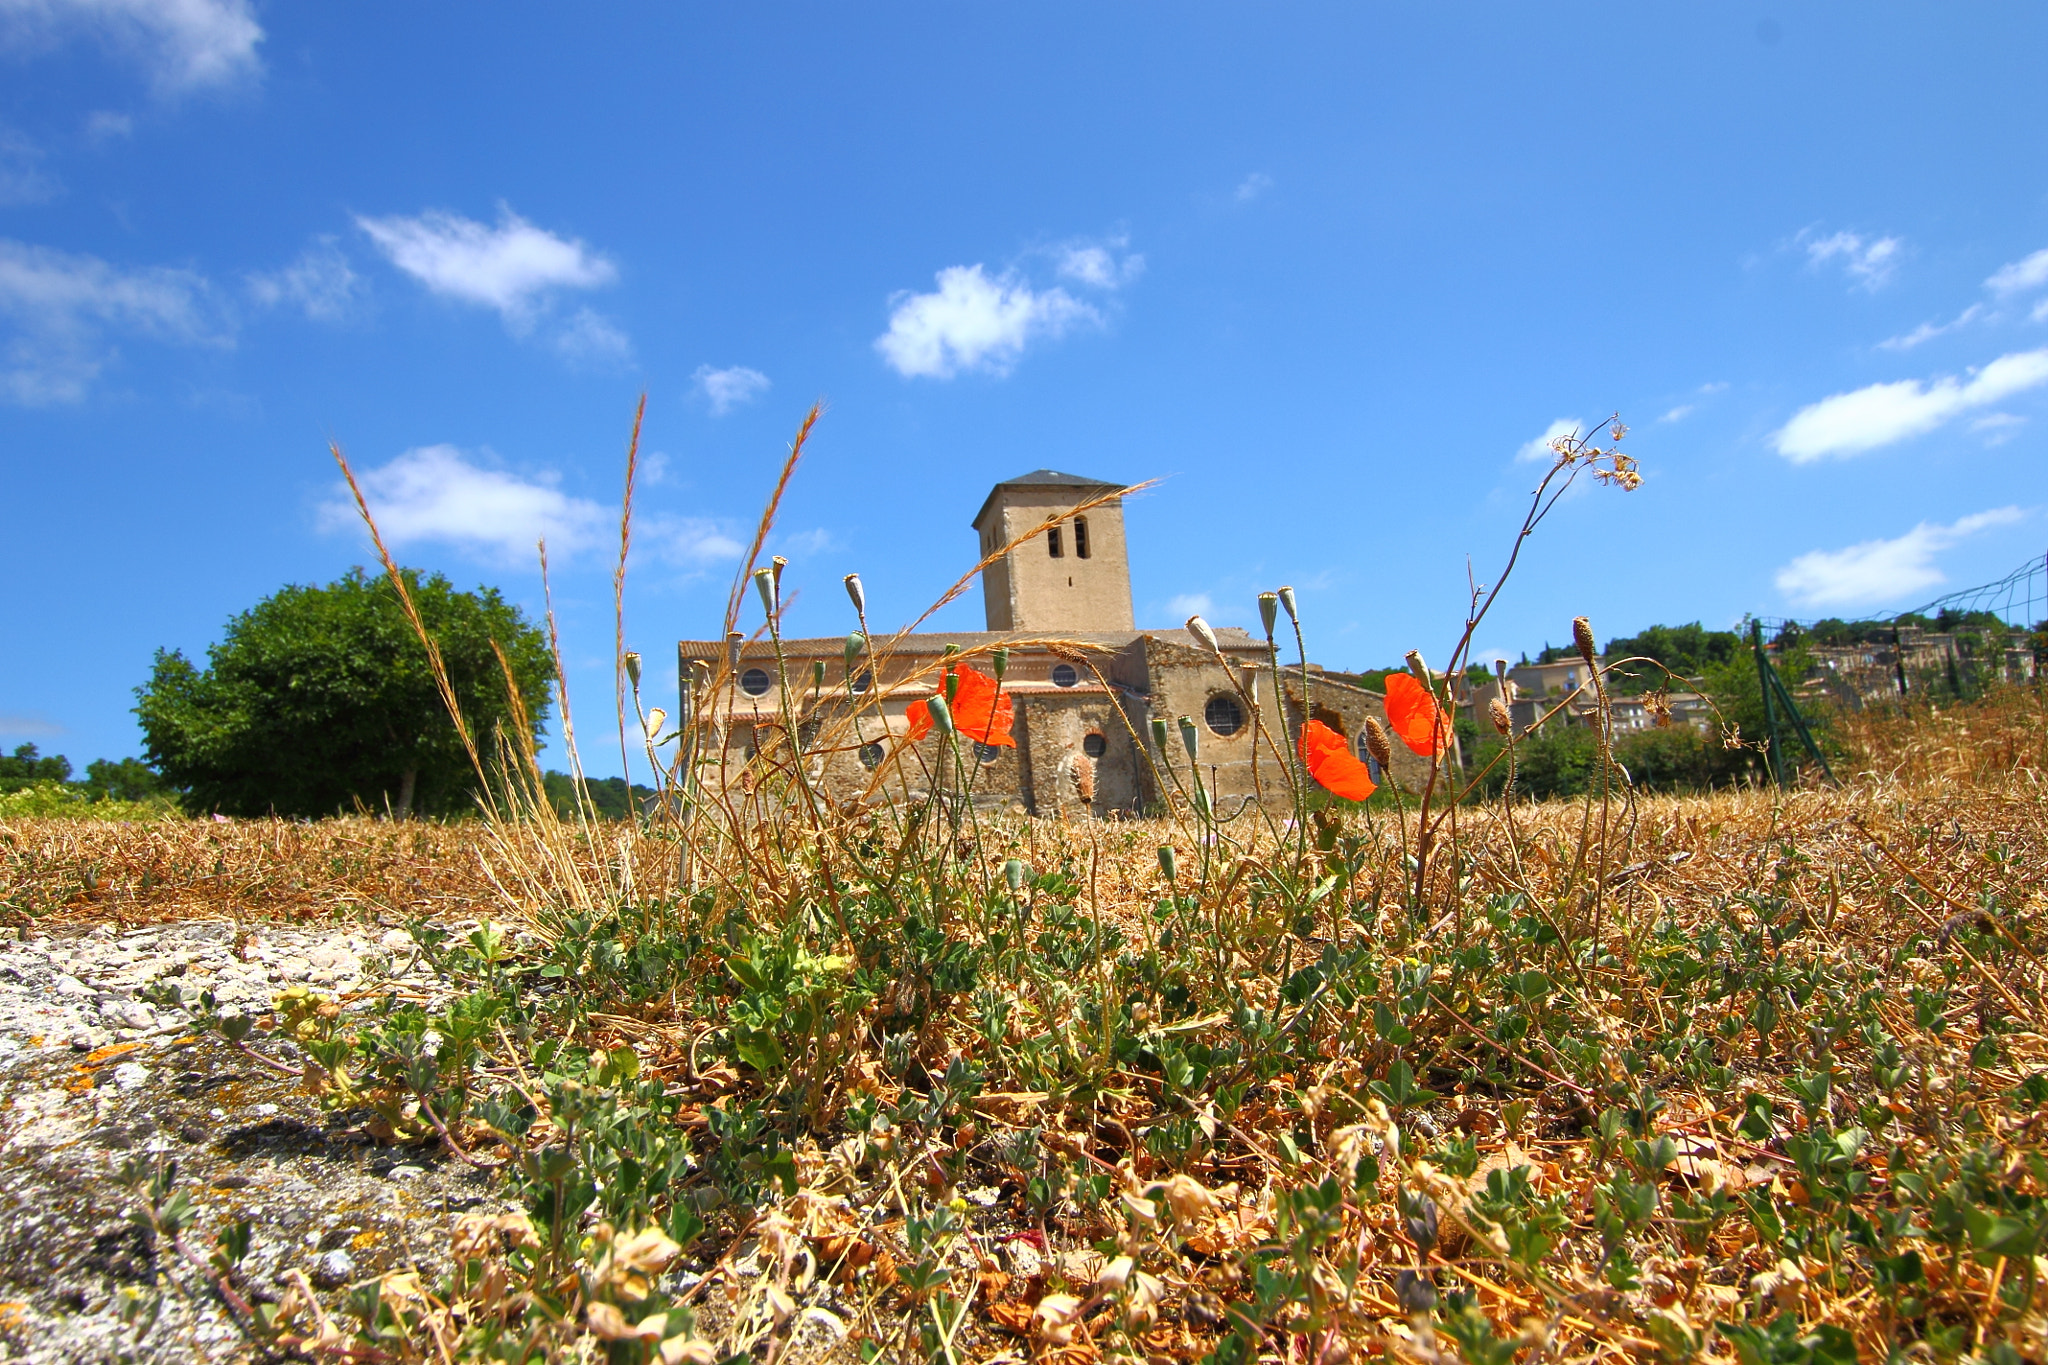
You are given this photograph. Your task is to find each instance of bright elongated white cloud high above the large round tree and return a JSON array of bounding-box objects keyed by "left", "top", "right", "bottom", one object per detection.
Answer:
[{"left": 356, "top": 207, "right": 618, "bottom": 334}]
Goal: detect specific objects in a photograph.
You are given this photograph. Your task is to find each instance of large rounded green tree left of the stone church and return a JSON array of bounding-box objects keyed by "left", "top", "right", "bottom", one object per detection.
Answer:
[{"left": 135, "top": 569, "right": 553, "bottom": 817}]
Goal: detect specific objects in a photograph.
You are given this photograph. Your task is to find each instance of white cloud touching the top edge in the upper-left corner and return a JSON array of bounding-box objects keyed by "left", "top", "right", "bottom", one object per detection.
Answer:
[{"left": 0, "top": 0, "right": 264, "bottom": 94}]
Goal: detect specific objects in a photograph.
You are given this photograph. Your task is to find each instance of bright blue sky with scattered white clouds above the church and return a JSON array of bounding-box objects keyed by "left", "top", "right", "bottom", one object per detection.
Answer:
[{"left": 0, "top": 0, "right": 2048, "bottom": 772}]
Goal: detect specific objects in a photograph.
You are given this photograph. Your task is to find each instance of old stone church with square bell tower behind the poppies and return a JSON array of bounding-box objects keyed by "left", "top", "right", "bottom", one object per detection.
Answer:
[{"left": 678, "top": 469, "right": 1419, "bottom": 819}]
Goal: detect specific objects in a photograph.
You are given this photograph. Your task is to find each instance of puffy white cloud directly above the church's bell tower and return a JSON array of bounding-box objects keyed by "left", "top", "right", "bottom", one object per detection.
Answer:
[{"left": 874, "top": 264, "right": 1102, "bottom": 379}]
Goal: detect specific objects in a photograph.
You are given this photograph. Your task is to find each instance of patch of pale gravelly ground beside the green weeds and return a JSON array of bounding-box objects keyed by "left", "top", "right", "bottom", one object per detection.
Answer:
[{"left": 0, "top": 921, "right": 494, "bottom": 1363}]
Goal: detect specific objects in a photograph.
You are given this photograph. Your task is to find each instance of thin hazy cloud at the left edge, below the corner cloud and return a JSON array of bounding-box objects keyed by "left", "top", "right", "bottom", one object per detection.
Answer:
[{"left": 0, "top": 239, "right": 222, "bottom": 405}]
